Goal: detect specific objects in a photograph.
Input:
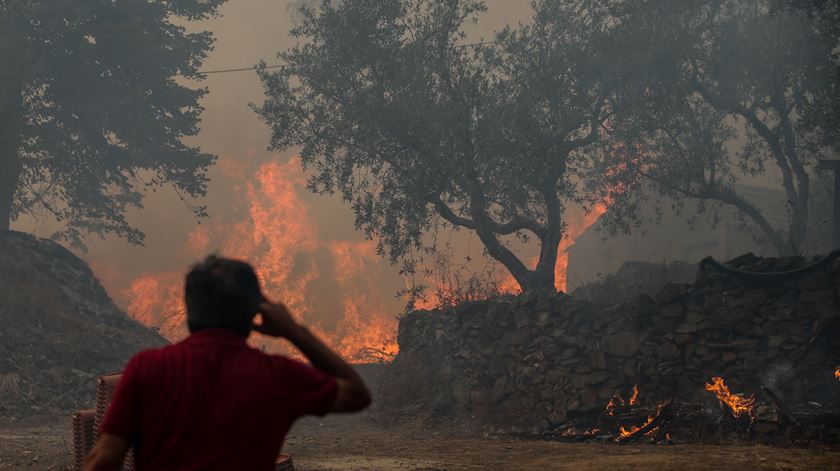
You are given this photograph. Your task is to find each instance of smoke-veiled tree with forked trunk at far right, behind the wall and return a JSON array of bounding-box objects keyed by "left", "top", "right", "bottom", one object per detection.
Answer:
[{"left": 600, "top": 0, "right": 840, "bottom": 255}]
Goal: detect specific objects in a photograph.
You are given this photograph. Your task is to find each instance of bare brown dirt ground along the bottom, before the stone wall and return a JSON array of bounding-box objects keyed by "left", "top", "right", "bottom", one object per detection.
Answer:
[{"left": 0, "top": 416, "right": 840, "bottom": 471}]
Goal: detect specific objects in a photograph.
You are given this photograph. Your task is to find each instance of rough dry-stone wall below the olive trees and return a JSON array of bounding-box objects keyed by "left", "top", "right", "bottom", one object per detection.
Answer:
[{"left": 381, "top": 256, "right": 840, "bottom": 426}]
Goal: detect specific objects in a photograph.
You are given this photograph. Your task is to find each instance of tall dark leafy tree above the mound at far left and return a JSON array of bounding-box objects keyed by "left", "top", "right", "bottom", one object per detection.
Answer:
[{"left": 0, "top": 0, "right": 224, "bottom": 249}]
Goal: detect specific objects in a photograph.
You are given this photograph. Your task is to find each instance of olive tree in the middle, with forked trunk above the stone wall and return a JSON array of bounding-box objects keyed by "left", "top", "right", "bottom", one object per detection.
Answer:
[{"left": 256, "top": 0, "right": 608, "bottom": 291}]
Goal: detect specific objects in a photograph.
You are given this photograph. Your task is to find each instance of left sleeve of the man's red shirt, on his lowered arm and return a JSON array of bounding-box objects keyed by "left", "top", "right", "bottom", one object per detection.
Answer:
[{"left": 100, "top": 355, "right": 142, "bottom": 443}]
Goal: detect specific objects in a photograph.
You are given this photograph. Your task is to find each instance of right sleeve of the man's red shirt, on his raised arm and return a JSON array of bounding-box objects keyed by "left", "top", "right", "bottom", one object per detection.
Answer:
[{"left": 281, "top": 358, "right": 338, "bottom": 417}]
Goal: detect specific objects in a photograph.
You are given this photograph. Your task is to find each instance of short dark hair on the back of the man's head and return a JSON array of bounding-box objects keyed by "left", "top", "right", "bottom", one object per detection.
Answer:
[{"left": 184, "top": 255, "right": 263, "bottom": 336}]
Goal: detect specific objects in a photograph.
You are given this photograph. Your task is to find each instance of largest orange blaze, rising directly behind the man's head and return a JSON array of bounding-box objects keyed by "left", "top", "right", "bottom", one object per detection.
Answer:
[{"left": 118, "top": 159, "right": 397, "bottom": 362}]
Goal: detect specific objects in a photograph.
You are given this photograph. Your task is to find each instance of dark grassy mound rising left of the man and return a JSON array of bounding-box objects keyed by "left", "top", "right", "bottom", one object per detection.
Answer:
[{"left": 0, "top": 231, "right": 165, "bottom": 420}]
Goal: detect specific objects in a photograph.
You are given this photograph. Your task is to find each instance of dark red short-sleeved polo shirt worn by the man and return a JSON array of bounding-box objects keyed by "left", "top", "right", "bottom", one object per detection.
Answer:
[{"left": 101, "top": 329, "right": 337, "bottom": 471}]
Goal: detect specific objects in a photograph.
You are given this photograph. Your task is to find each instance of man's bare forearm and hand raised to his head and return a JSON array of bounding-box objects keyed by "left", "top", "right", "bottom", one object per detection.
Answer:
[{"left": 254, "top": 301, "right": 371, "bottom": 412}]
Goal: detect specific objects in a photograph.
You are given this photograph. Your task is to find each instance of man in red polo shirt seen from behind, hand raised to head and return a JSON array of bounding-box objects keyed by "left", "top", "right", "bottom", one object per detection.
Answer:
[{"left": 84, "top": 256, "right": 370, "bottom": 471}]
